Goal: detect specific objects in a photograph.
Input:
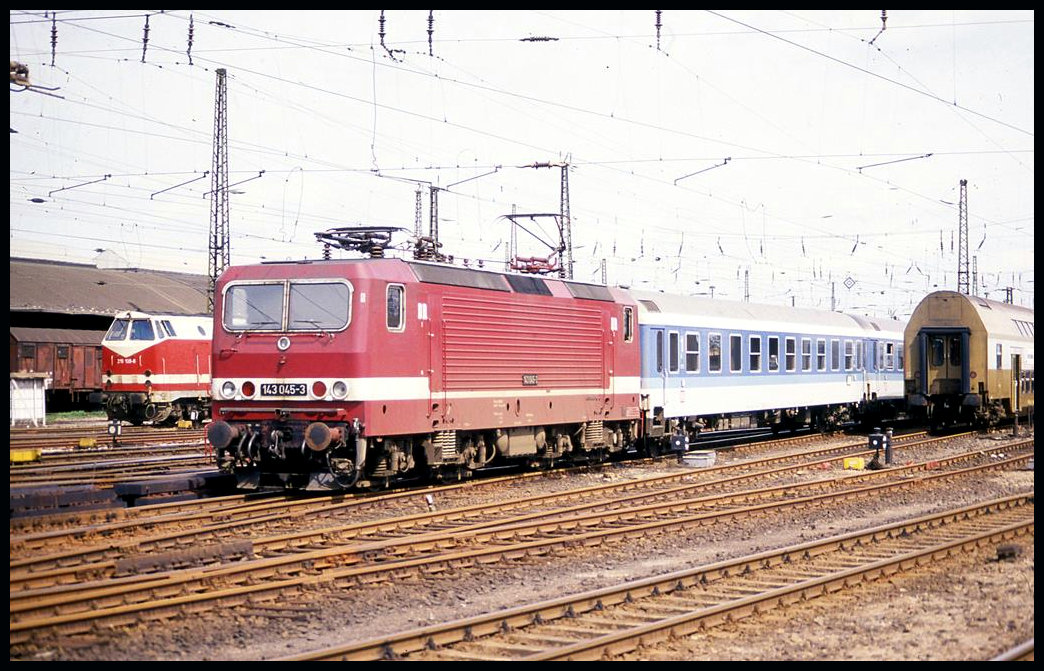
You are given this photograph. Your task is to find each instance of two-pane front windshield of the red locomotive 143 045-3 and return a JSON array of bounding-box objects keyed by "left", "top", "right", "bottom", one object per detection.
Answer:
[{"left": 221, "top": 281, "right": 351, "bottom": 331}]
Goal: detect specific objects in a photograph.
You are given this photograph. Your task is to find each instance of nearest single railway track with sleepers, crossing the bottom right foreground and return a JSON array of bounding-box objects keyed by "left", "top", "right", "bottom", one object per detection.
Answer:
[{"left": 281, "top": 495, "right": 1035, "bottom": 662}]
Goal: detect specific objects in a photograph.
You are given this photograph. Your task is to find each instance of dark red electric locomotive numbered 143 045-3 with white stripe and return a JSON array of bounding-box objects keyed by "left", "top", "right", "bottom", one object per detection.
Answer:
[{"left": 208, "top": 249, "right": 640, "bottom": 489}]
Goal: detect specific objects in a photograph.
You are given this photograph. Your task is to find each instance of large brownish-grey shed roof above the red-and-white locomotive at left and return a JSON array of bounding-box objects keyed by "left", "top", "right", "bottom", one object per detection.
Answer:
[{"left": 10, "top": 259, "right": 208, "bottom": 315}]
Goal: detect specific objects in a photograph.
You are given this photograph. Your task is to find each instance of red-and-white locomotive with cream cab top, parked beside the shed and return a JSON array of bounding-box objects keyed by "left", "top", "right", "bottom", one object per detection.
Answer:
[{"left": 91, "top": 312, "right": 213, "bottom": 425}]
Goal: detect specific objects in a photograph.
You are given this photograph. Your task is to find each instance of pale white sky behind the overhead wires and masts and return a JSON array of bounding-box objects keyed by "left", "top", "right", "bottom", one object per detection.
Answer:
[{"left": 10, "top": 9, "right": 1035, "bottom": 318}]
